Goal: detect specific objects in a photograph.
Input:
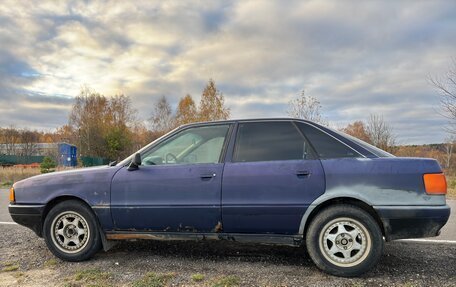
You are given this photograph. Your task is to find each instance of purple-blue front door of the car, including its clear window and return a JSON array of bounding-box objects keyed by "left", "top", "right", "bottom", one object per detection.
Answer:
[{"left": 111, "top": 124, "right": 229, "bottom": 232}]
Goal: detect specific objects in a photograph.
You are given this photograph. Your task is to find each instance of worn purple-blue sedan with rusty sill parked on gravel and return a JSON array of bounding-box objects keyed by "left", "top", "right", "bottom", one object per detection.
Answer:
[{"left": 9, "top": 119, "right": 450, "bottom": 276}]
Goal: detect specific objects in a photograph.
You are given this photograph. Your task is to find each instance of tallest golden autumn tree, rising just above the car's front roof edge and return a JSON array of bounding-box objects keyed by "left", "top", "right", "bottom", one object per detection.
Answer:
[{"left": 198, "top": 79, "right": 230, "bottom": 122}]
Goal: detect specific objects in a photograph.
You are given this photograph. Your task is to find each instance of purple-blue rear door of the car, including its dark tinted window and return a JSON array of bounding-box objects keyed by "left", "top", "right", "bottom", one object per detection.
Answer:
[{"left": 222, "top": 121, "right": 325, "bottom": 234}]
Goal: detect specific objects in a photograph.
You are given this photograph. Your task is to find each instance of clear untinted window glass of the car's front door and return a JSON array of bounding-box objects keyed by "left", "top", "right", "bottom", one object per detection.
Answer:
[{"left": 141, "top": 125, "right": 229, "bottom": 165}]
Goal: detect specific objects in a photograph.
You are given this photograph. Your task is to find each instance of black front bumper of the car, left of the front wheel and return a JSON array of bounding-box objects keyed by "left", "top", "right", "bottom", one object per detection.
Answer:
[{"left": 8, "top": 204, "right": 45, "bottom": 237}]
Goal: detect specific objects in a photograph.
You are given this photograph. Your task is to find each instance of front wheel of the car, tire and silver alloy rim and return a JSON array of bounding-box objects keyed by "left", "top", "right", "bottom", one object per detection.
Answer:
[{"left": 43, "top": 200, "right": 101, "bottom": 261}]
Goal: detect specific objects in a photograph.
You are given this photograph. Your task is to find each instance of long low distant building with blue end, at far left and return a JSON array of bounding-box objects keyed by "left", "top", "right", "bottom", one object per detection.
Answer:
[{"left": 0, "top": 142, "right": 78, "bottom": 166}]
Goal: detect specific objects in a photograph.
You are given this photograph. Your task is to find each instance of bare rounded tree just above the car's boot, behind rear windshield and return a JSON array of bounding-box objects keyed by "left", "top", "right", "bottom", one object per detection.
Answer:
[{"left": 366, "top": 114, "right": 396, "bottom": 152}]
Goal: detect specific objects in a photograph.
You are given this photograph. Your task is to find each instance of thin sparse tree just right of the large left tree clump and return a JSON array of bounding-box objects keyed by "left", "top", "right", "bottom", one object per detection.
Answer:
[{"left": 149, "top": 96, "right": 175, "bottom": 135}]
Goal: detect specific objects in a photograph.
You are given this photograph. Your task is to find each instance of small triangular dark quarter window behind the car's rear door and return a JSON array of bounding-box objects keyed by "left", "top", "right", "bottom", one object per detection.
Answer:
[{"left": 297, "top": 123, "right": 360, "bottom": 159}]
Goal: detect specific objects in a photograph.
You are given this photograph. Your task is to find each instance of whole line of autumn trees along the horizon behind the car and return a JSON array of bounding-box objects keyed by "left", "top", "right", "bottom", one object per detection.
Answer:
[{"left": 0, "top": 59, "right": 456, "bottom": 168}]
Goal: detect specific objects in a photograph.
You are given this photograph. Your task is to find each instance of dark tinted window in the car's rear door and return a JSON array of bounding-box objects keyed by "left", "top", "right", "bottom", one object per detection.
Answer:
[{"left": 233, "top": 122, "right": 314, "bottom": 162}]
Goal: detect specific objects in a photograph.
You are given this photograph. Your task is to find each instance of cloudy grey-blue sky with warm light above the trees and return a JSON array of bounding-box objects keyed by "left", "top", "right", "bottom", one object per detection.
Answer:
[{"left": 0, "top": 0, "right": 456, "bottom": 144}]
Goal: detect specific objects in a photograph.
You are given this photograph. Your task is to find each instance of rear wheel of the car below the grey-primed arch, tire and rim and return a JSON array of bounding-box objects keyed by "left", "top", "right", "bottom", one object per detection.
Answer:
[{"left": 306, "top": 204, "right": 383, "bottom": 277}]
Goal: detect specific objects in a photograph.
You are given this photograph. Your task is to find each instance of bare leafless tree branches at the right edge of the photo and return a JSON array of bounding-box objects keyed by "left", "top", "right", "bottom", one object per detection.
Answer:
[{"left": 430, "top": 59, "right": 456, "bottom": 134}]
